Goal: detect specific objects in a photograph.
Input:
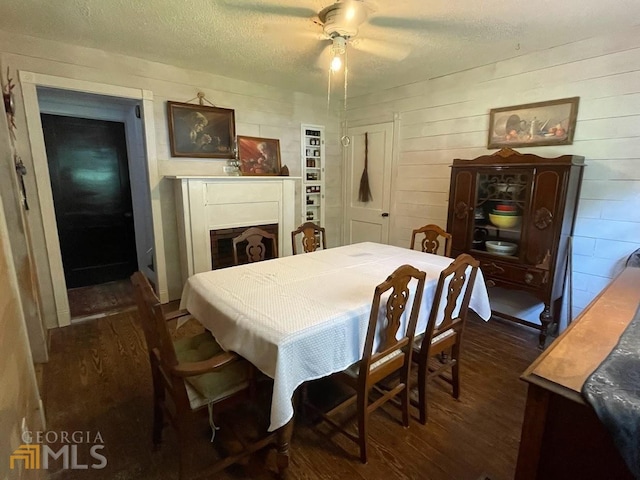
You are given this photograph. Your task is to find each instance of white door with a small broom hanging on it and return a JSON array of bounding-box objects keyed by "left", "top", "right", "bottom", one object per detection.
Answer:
[{"left": 345, "top": 123, "right": 393, "bottom": 244}]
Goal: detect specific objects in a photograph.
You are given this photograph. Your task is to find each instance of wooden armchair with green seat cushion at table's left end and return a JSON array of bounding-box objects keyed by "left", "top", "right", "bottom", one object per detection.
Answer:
[{"left": 131, "top": 272, "right": 276, "bottom": 480}]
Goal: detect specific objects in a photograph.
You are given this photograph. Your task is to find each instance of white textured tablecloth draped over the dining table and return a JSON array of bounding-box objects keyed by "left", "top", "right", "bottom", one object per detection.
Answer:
[{"left": 180, "top": 243, "right": 491, "bottom": 431}]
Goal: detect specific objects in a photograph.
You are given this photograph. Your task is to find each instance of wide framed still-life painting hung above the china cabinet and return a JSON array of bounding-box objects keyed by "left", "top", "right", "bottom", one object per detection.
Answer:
[{"left": 488, "top": 97, "right": 580, "bottom": 148}]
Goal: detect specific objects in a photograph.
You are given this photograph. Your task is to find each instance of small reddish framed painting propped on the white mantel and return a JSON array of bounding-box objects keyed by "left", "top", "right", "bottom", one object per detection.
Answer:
[{"left": 238, "top": 135, "right": 280, "bottom": 175}]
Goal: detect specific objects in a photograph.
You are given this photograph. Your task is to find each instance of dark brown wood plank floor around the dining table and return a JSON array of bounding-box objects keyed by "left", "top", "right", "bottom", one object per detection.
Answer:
[{"left": 43, "top": 311, "right": 539, "bottom": 480}]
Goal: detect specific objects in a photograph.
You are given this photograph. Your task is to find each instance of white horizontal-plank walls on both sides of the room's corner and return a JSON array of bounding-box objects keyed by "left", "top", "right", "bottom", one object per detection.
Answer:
[{"left": 5, "top": 28, "right": 640, "bottom": 326}]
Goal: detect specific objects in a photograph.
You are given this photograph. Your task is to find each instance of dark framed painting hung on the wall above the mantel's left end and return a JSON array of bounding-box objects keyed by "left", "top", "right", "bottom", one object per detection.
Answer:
[{"left": 167, "top": 102, "right": 236, "bottom": 158}]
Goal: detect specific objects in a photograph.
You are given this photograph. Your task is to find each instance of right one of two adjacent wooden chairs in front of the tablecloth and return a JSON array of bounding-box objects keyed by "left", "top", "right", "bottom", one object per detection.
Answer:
[{"left": 412, "top": 253, "right": 480, "bottom": 424}]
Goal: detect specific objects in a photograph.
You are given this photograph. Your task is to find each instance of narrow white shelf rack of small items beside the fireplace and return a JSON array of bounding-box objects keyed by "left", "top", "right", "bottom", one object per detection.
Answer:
[{"left": 300, "top": 124, "right": 325, "bottom": 226}]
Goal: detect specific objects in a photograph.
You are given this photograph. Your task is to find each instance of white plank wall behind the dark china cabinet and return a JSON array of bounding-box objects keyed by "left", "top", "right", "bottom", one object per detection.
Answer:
[{"left": 348, "top": 27, "right": 640, "bottom": 316}]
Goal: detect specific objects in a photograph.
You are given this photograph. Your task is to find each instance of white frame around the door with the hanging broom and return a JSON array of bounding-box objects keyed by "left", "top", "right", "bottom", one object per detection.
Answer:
[{"left": 342, "top": 113, "right": 400, "bottom": 245}]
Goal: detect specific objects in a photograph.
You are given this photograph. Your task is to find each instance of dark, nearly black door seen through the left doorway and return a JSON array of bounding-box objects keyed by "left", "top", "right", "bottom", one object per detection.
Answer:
[{"left": 41, "top": 114, "right": 138, "bottom": 288}]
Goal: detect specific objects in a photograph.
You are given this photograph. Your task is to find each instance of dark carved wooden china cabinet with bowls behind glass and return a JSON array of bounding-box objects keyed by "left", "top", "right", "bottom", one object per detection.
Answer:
[{"left": 447, "top": 148, "right": 584, "bottom": 348}]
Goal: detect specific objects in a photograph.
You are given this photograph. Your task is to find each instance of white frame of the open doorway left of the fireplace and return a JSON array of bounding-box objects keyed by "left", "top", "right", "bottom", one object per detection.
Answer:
[{"left": 19, "top": 71, "right": 169, "bottom": 327}]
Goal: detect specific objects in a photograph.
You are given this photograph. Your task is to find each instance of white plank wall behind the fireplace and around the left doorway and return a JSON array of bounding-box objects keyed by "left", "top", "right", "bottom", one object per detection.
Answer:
[{"left": 0, "top": 31, "right": 342, "bottom": 327}]
